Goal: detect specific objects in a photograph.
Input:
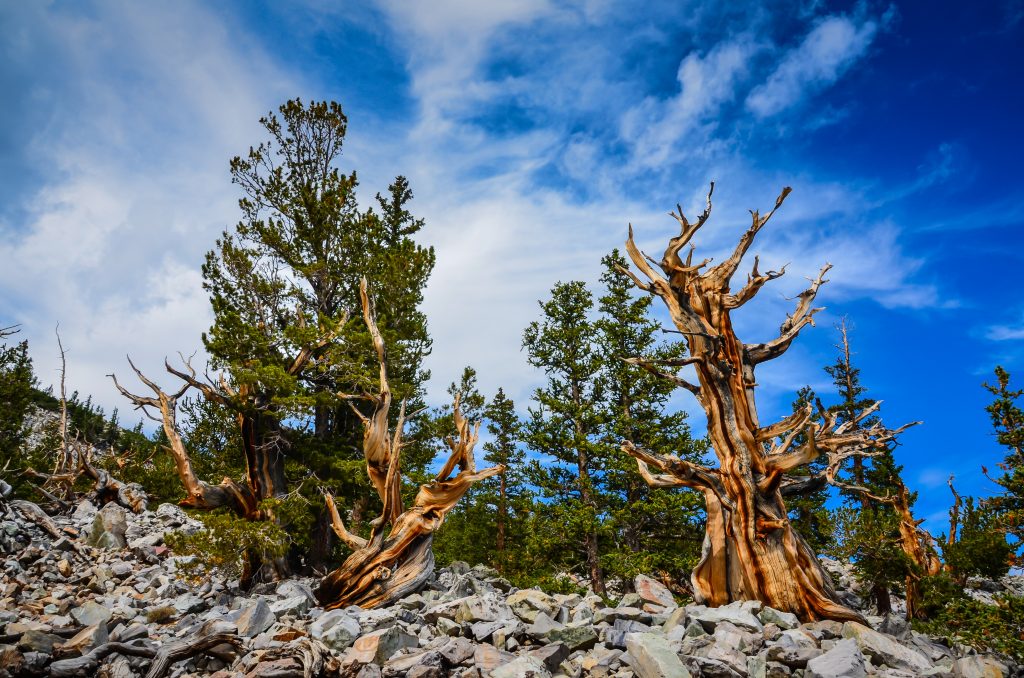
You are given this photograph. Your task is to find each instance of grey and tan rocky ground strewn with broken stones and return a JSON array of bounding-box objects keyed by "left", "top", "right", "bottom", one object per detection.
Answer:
[{"left": 0, "top": 501, "right": 1024, "bottom": 678}]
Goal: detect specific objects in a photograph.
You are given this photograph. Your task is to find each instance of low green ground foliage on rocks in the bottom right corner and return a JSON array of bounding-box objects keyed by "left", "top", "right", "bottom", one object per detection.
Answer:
[{"left": 913, "top": 589, "right": 1024, "bottom": 661}]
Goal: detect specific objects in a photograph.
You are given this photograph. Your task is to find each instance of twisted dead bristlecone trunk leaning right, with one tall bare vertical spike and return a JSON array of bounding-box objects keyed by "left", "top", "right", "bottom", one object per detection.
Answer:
[{"left": 316, "top": 279, "right": 502, "bottom": 609}]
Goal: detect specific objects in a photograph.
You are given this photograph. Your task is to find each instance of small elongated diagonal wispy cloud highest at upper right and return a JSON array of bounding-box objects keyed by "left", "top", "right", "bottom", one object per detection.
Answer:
[{"left": 746, "top": 16, "right": 879, "bottom": 118}]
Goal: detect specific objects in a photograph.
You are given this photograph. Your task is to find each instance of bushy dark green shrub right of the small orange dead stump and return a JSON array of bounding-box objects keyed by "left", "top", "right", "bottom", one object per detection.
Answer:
[{"left": 940, "top": 497, "right": 1014, "bottom": 584}]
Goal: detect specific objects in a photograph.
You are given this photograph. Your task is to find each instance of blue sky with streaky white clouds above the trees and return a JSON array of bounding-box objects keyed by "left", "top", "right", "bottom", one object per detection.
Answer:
[{"left": 0, "top": 0, "right": 1024, "bottom": 529}]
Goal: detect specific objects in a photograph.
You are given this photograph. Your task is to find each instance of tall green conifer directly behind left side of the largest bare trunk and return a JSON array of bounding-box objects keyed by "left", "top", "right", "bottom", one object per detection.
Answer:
[{"left": 594, "top": 255, "right": 708, "bottom": 582}]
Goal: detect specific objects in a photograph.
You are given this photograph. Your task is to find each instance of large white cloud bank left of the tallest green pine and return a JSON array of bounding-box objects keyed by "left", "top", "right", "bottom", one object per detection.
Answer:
[{"left": 0, "top": 2, "right": 296, "bottom": 420}]
